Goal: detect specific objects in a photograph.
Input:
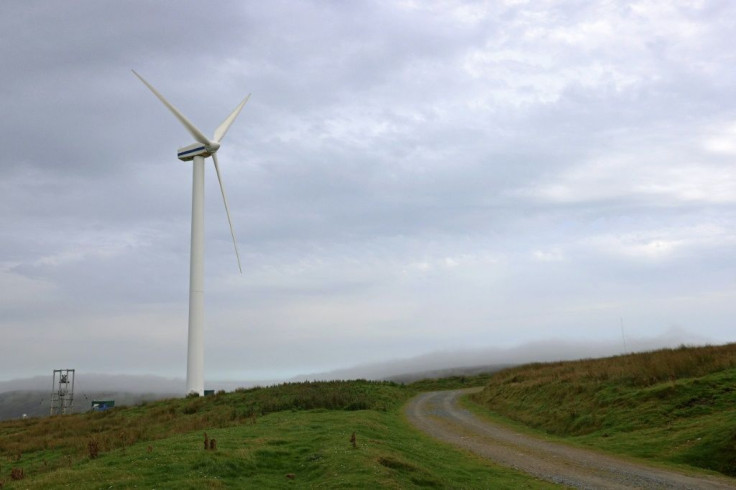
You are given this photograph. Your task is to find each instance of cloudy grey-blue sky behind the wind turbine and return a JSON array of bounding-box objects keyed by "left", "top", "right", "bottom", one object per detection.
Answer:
[{"left": 0, "top": 0, "right": 736, "bottom": 386}]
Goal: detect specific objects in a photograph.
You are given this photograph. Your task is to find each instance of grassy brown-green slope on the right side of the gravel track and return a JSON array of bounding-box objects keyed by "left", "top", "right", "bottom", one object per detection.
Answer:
[{"left": 473, "top": 344, "right": 736, "bottom": 476}]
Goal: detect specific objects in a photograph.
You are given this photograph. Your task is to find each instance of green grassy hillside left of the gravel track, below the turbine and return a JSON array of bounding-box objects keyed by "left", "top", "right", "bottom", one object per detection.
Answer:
[{"left": 0, "top": 378, "right": 551, "bottom": 488}]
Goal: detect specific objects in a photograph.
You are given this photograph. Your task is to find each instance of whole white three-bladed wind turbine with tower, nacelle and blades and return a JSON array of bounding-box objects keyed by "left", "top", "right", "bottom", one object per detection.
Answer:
[{"left": 132, "top": 70, "right": 250, "bottom": 396}]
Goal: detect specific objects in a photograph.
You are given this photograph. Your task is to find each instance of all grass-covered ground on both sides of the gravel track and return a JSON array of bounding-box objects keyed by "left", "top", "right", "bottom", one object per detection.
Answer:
[{"left": 5, "top": 344, "right": 736, "bottom": 488}]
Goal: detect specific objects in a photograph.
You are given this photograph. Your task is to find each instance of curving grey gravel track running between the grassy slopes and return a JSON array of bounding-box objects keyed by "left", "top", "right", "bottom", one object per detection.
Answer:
[{"left": 405, "top": 390, "right": 736, "bottom": 490}]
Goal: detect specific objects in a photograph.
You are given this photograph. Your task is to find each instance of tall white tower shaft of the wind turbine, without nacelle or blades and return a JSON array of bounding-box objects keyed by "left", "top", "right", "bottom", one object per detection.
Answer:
[{"left": 187, "top": 156, "right": 204, "bottom": 396}]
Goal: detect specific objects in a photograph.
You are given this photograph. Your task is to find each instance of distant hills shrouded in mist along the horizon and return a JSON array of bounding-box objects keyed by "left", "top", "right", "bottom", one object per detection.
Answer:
[{"left": 0, "top": 332, "right": 703, "bottom": 420}]
